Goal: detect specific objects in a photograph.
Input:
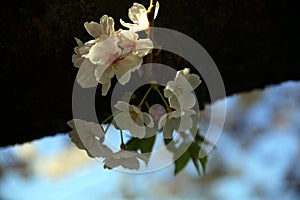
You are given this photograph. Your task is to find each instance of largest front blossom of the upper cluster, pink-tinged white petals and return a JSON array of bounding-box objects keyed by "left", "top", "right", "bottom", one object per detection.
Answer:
[{"left": 77, "top": 37, "right": 143, "bottom": 96}]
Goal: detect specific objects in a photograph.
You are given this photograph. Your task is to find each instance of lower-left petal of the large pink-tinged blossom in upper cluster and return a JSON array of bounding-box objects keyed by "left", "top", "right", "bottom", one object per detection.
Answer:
[{"left": 76, "top": 59, "right": 98, "bottom": 88}]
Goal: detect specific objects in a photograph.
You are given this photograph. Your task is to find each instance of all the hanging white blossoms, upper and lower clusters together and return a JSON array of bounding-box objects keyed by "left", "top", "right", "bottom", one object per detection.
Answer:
[{"left": 68, "top": 2, "right": 205, "bottom": 173}]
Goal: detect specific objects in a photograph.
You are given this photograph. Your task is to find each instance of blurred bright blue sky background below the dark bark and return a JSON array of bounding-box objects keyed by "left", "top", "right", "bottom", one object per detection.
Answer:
[{"left": 0, "top": 82, "right": 300, "bottom": 200}]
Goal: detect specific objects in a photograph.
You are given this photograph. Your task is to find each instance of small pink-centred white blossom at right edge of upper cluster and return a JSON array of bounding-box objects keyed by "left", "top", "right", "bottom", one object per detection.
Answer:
[{"left": 118, "top": 30, "right": 153, "bottom": 57}]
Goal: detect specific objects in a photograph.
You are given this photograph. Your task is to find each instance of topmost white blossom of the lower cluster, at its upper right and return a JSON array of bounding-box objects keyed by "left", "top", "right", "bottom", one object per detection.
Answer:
[{"left": 164, "top": 68, "right": 201, "bottom": 110}]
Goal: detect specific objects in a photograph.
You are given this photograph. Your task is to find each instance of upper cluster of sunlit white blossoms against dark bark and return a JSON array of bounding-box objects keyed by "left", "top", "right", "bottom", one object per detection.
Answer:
[{"left": 72, "top": 3, "right": 158, "bottom": 96}]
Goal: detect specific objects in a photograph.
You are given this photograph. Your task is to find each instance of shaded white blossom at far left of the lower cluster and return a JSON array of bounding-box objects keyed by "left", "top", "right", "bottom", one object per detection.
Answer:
[{"left": 67, "top": 119, "right": 112, "bottom": 158}]
